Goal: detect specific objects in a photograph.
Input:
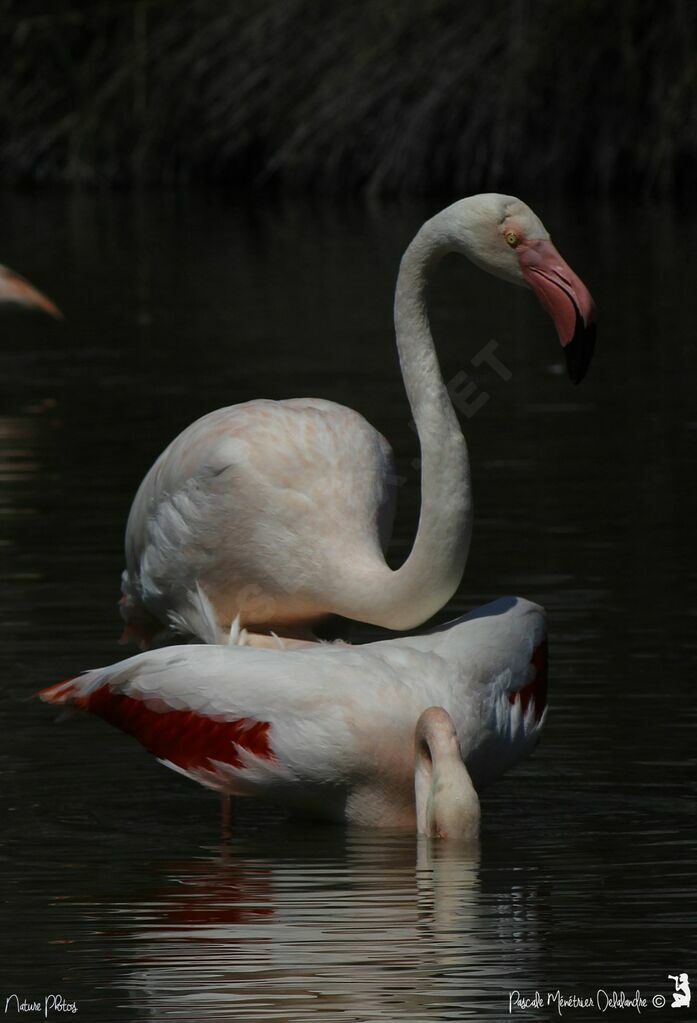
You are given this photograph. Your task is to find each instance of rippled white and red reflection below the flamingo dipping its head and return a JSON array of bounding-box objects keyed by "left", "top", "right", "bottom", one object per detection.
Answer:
[{"left": 116, "top": 830, "right": 500, "bottom": 1021}]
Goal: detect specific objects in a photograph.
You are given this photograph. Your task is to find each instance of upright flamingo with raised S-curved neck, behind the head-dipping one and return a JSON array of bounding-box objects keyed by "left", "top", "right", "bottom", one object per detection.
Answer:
[{"left": 121, "top": 194, "right": 595, "bottom": 647}]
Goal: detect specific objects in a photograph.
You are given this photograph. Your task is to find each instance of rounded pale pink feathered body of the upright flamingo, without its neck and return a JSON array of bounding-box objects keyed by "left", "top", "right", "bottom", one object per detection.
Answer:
[{"left": 122, "top": 399, "right": 394, "bottom": 639}]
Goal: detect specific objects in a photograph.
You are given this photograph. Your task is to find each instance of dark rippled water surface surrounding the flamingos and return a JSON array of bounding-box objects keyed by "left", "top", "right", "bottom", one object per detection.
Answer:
[{"left": 0, "top": 194, "right": 697, "bottom": 1023}]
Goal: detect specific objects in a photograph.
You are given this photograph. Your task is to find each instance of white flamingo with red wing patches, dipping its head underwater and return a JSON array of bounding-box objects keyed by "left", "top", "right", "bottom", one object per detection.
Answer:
[{"left": 39, "top": 597, "right": 547, "bottom": 841}]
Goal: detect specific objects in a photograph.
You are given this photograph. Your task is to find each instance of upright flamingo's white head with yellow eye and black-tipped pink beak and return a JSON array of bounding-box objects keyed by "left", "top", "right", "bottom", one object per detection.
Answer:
[{"left": 432, "top": 192, "right": 596, "bottom": 384}]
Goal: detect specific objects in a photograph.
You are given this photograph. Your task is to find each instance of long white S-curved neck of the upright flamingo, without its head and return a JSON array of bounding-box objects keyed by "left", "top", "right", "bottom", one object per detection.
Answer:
[{"left": 337, "top": 215, "right": 472, "bottom": 629}]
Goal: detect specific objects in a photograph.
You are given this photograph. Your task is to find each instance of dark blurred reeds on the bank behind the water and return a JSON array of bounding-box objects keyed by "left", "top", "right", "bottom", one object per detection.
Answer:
[{"left": 0, "top": 0, "right": 697, "bottom": 194}]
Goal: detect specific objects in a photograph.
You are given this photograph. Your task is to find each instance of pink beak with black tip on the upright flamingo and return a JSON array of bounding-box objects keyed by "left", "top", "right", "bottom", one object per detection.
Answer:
[{"left": 516, "top": 238, "right": 596, "bottom": 384}]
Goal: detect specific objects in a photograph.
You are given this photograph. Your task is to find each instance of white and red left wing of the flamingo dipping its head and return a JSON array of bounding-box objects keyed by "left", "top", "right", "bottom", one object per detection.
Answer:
[{"left": 39, "top": 646, "right": 413, "bottom": 795}]
